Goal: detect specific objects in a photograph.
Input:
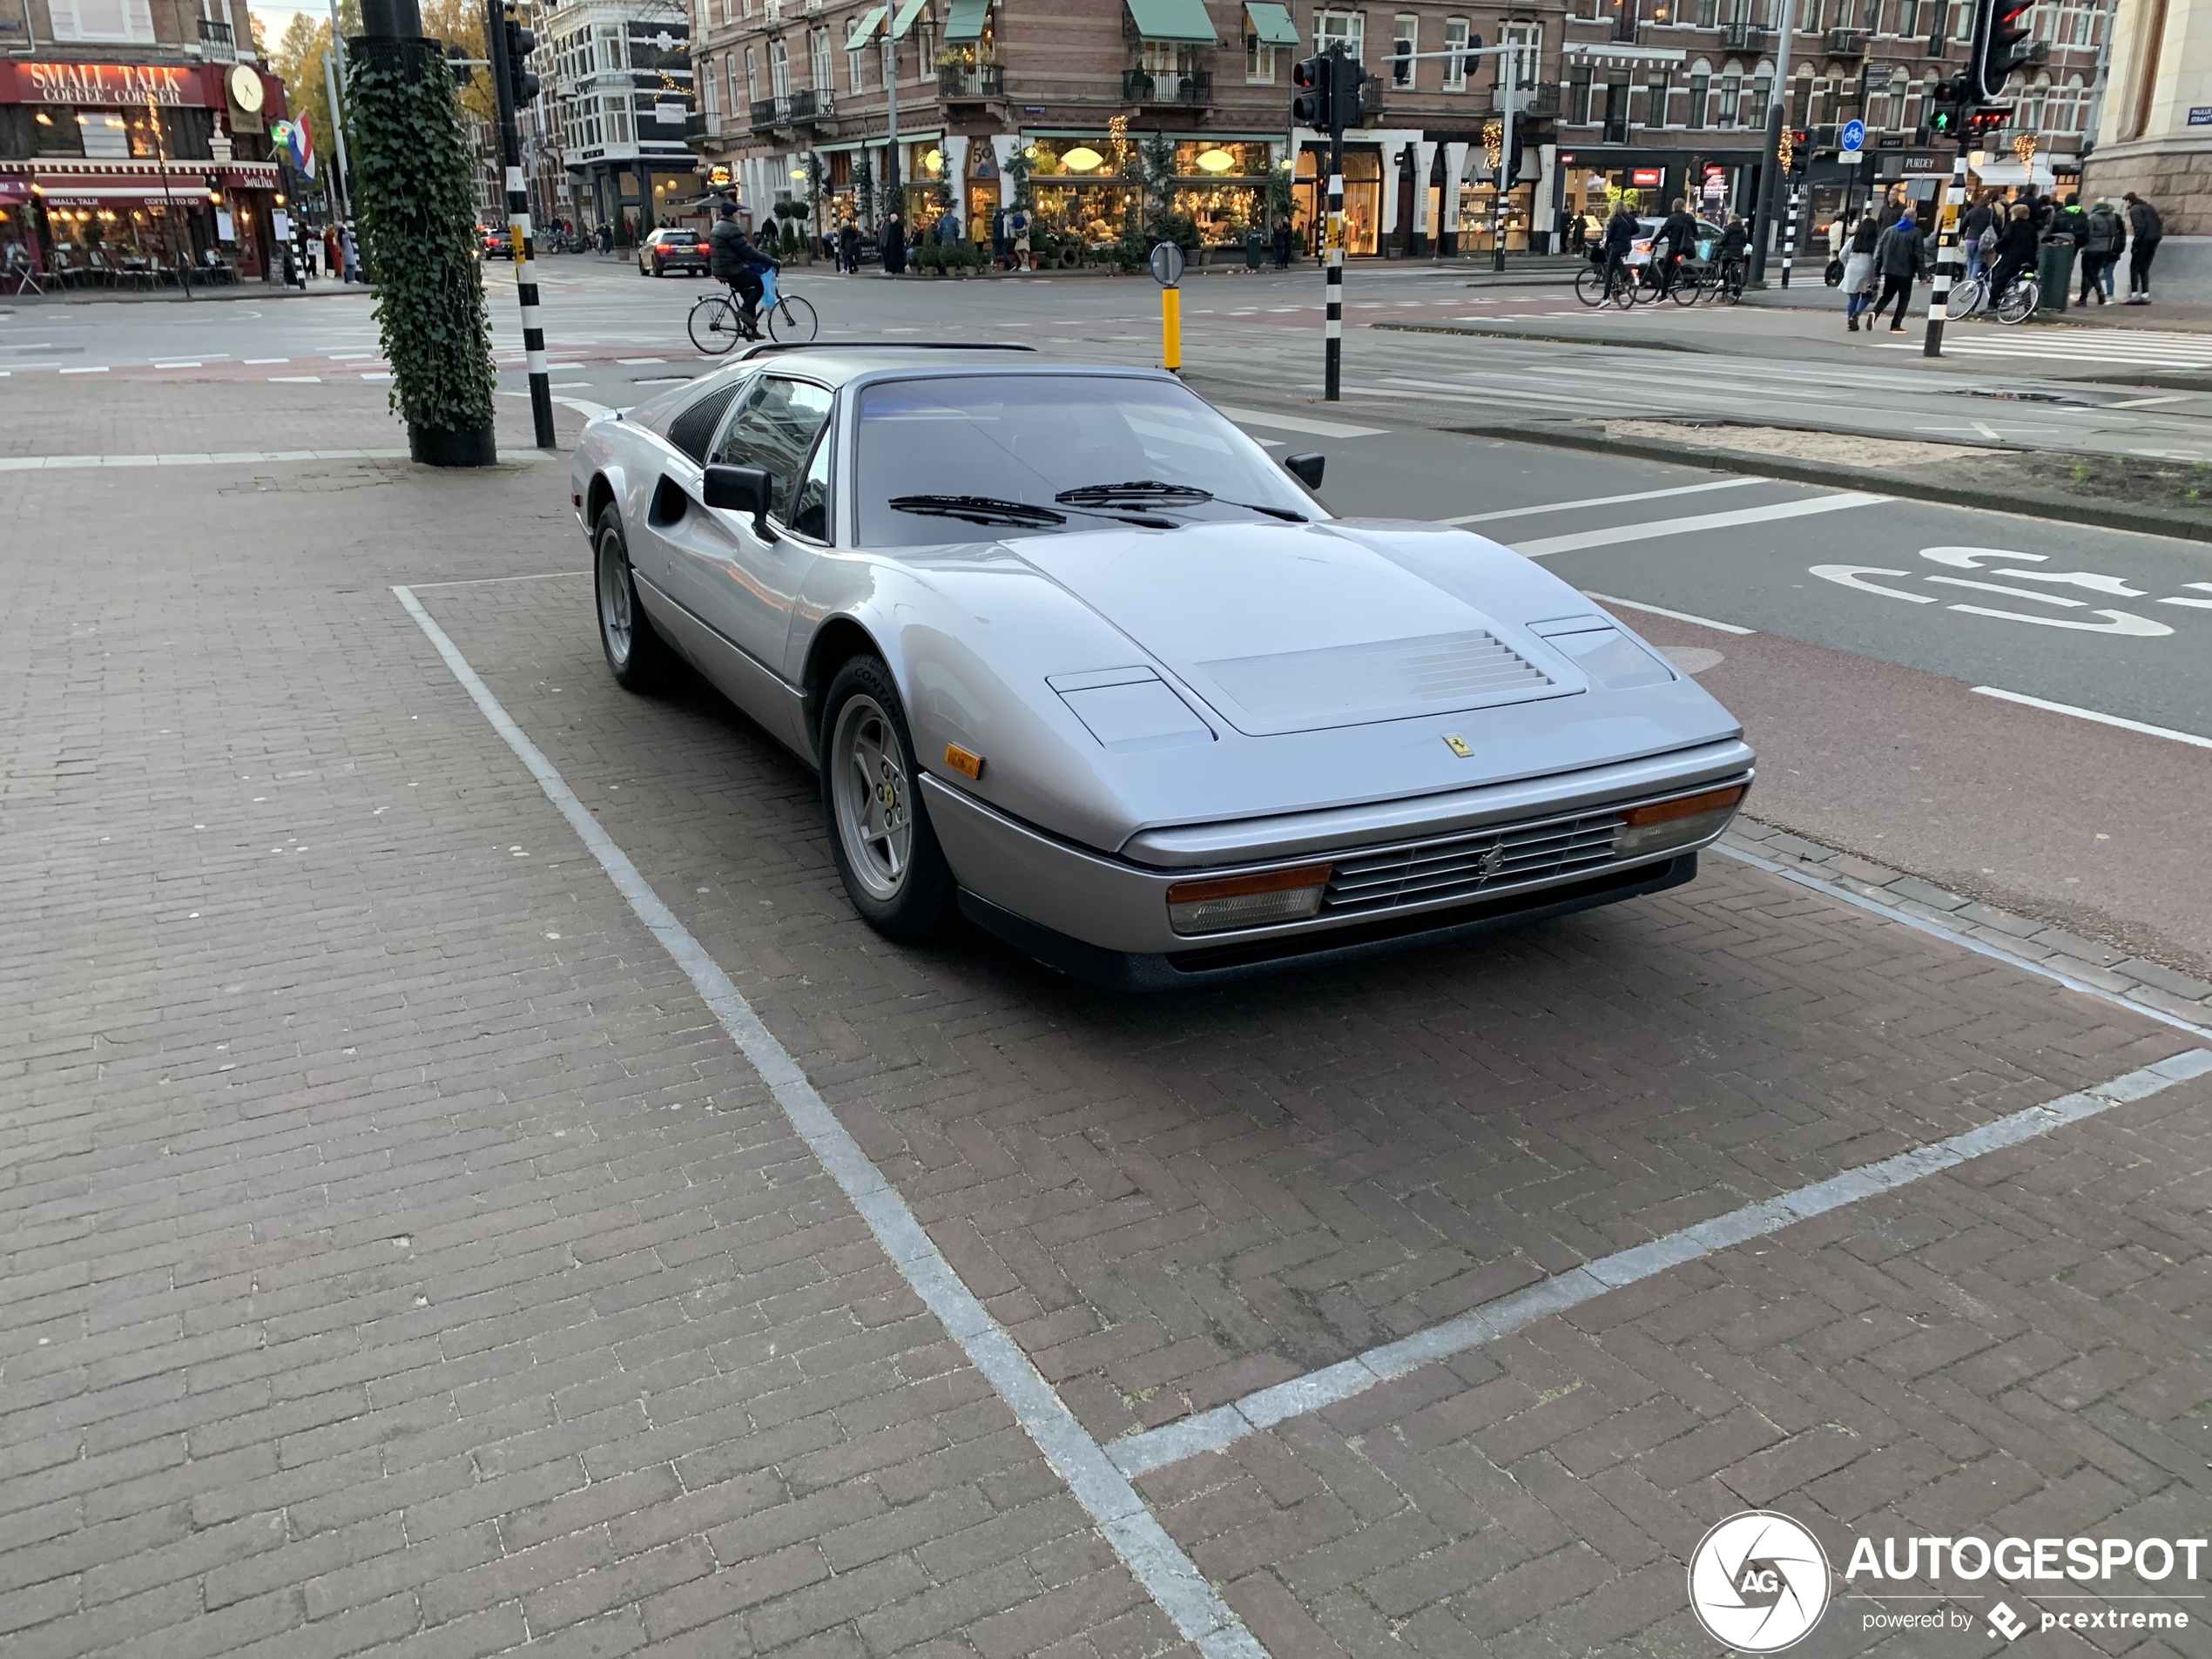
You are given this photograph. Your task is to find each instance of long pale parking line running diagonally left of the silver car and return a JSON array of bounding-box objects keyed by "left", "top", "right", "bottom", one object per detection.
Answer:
[{"left": 392, "top": 586, "right": 1267, "bottom": 1659}]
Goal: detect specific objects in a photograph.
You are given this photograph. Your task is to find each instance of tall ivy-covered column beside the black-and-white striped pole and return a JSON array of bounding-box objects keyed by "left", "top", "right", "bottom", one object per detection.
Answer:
[{"left": 347, "top": 0, "right": 498, "bottom": 467}]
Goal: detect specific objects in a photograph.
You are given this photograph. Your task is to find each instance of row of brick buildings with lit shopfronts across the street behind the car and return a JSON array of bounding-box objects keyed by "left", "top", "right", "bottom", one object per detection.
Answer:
[{"left": 692, "top": 0, "right": 2106, "bottom": 254}]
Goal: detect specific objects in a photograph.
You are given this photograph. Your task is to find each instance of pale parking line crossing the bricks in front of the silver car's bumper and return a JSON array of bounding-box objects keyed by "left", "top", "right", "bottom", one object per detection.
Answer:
[{"left": 1106, "top": 1049, "right": 2212, "bottom": 1475}]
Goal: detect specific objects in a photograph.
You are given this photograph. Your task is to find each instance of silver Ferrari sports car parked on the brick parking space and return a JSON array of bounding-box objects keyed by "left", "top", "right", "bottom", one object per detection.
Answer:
[{"left": 573, "top": 345, "right": 1752, "bottom": 988}]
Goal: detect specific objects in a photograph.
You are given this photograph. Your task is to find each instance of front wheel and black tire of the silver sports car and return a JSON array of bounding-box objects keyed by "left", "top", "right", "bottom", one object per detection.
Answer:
[{"left": 816, "top": 657, "right": 958, "bottom": 945}]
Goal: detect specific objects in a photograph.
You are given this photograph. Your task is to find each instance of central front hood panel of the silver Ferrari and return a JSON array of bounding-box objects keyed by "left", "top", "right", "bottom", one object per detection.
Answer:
[{"left": 1013, "top": 522, "right": 1588, "bottom": 737}]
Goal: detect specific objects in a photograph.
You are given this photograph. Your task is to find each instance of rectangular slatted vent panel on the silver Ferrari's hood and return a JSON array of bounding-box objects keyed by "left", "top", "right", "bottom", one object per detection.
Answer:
[{"left": 1199, "top": 628, "right": 1551, "bottom": 732}]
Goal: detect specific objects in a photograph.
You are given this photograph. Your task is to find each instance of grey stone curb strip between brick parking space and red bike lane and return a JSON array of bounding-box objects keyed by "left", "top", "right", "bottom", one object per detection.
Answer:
[{"left": 1721, "top": 816, "right": 2212, "bottom": 1027}]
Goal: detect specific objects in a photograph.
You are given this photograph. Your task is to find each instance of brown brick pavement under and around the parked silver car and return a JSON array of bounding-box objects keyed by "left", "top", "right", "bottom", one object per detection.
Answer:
[{"left": 0, "top": 388, "right": 2212, "bottom": 1659}]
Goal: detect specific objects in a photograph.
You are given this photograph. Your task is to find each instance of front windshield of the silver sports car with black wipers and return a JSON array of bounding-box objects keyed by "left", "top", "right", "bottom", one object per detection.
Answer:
[{"left": 859, "top": 374, "right": 1320, "bottom": 546}]
